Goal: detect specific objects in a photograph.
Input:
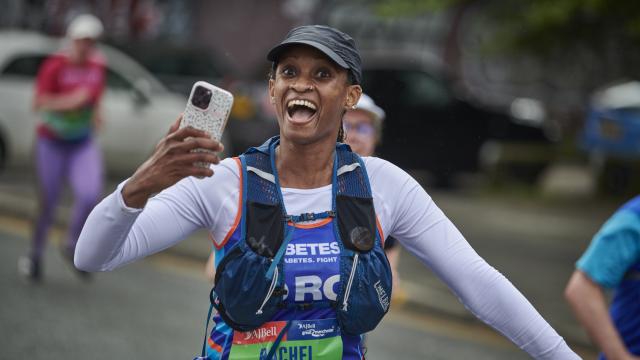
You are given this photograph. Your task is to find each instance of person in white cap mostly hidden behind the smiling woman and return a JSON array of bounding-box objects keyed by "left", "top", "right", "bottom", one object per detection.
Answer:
[{"left": 342, "top": 93, "right": 406, "bottom": 302}]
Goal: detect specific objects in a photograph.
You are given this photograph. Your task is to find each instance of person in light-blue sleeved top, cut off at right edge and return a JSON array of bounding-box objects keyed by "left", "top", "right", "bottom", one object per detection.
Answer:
[{"left": 565, "top": 196, "right": 640, "bottom": 360}]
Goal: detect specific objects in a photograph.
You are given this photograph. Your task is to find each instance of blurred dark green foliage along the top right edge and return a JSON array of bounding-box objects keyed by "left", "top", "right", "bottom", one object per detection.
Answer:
[{"left": 373, "top": 0, "right": 640, "bottom": 53}]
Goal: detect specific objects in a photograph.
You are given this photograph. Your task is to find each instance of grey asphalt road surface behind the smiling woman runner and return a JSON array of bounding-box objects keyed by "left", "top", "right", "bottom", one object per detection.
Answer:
[{"left": 0, "top": 216, "right": 544, "bottom": 360}]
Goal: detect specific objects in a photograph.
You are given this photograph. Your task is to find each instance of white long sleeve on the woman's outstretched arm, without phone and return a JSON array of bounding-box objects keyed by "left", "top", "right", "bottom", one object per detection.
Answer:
[{"left": 365, "top": 158, "right": 579, "bottom": 359}]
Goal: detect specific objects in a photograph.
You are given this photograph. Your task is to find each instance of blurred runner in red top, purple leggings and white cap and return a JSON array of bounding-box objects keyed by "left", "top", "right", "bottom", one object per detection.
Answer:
[{"left": 19, "top": 14, "right": 105, "bottom": 280}]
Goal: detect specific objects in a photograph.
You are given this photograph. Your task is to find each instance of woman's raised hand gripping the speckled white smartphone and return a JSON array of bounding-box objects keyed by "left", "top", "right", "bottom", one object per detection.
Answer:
[{"left": 122, "top": 116, "right": 224, "bottom": 208}]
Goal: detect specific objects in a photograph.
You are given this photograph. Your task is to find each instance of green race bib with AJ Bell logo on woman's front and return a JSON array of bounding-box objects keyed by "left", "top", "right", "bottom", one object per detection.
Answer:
[{"left": 229, "top": 319, "right": 342, "bottom": 360}]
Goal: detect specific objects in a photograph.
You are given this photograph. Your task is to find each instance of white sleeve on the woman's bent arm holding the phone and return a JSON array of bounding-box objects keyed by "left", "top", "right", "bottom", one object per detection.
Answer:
[{"left": 74, "top": 159, "right": 239, "bottom": 271}]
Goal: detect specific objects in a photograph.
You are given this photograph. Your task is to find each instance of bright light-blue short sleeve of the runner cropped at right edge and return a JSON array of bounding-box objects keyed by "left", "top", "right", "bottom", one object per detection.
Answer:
[{"left": 576, "top": 210, "right": 640, "bottom": 288}]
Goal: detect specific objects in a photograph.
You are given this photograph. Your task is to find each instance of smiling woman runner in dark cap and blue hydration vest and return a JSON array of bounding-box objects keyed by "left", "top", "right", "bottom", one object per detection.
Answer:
[{"left": 75, "top": 25, "right": 579, "bottom": 359}]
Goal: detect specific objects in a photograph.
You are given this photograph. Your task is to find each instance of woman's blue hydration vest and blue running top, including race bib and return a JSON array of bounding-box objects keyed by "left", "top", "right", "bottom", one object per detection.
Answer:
[{"left": 202, "top": 137, "right": 391, "bottom": 359}]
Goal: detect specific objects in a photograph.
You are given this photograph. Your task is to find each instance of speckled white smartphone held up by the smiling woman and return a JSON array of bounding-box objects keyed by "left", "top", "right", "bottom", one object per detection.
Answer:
[{"left": 180, "top": 81, "right": 233, "bottom": 168}]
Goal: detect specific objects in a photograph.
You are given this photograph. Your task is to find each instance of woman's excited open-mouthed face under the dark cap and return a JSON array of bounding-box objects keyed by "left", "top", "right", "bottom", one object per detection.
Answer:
[{"left": 269, "top": 45, "right": 362, "bottom": 144}]
